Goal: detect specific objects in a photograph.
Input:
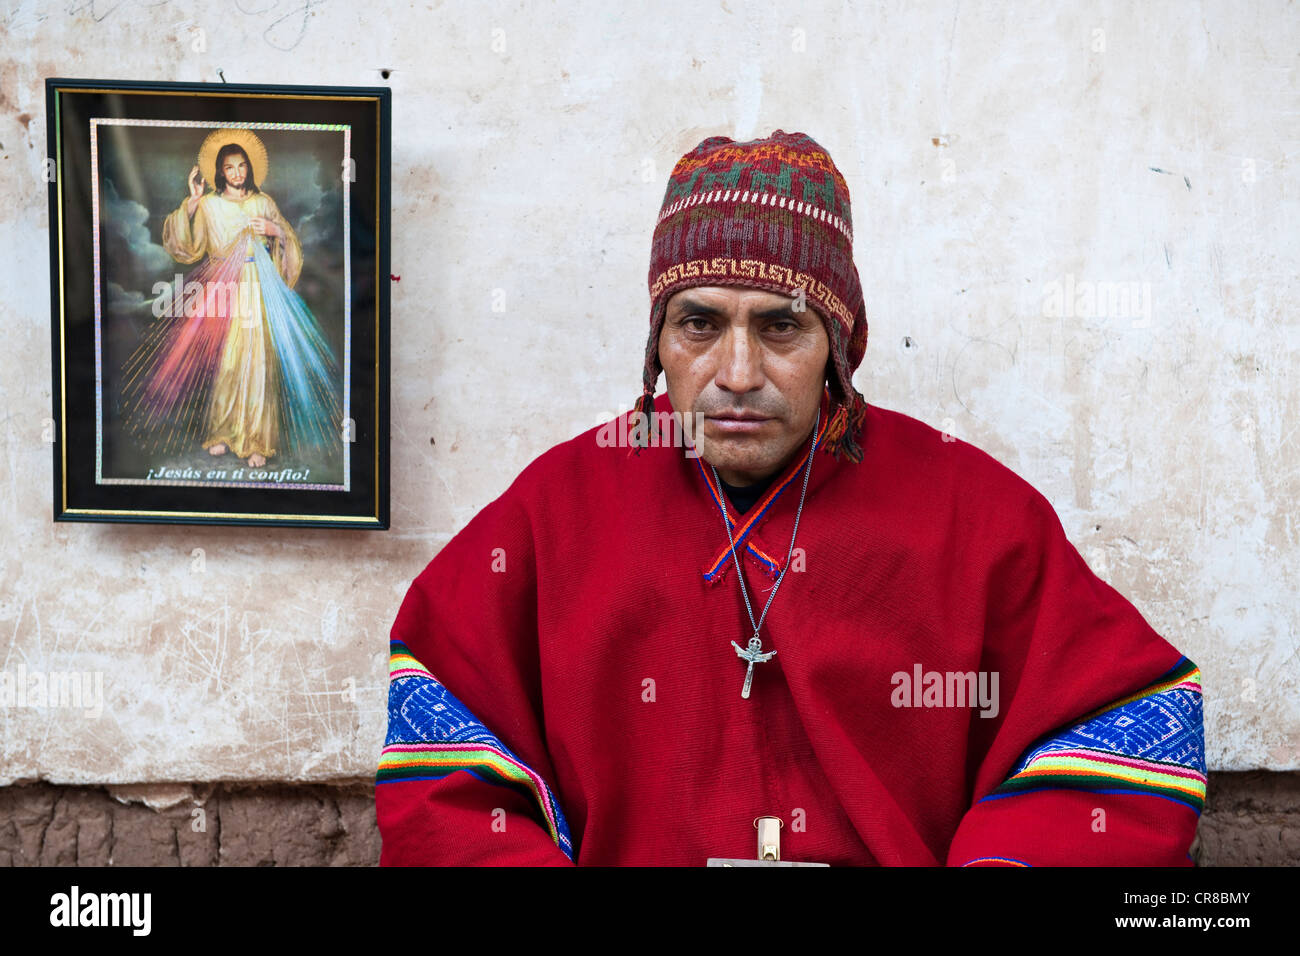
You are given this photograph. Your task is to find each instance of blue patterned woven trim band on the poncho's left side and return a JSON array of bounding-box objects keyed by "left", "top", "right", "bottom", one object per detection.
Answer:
[{"left": 374, "top": 641, "right": 573, "bottom": 860}]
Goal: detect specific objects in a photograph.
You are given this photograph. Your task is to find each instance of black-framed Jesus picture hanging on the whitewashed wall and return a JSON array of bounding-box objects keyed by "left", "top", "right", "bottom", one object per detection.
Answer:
[{"left": 46, "top": 79, "right": 391, "bottom": 528}]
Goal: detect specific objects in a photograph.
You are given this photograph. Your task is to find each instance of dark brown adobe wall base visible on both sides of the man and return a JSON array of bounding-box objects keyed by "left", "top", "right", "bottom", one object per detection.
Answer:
[{"left": 0, "top": 771, "right": 1300, "bottom": 866}]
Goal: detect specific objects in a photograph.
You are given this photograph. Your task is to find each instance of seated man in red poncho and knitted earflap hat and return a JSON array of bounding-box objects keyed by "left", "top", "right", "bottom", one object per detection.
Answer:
[{"left": 376, "top": 130, "right": 1205, "bottom": 866}]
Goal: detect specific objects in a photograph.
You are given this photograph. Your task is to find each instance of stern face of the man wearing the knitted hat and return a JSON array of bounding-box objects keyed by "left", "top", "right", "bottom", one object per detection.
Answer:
[{"left": 659, "top": 286, "right": 831, "bottom": 485}]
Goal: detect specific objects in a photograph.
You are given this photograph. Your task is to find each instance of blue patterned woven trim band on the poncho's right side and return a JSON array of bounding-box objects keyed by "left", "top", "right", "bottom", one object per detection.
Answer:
[{"left": 984, "top": 657, "right": 1205, "bottom": 813}]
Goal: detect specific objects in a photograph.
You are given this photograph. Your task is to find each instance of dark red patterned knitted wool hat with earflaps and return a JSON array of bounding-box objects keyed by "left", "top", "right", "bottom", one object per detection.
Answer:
[{"left": 637, "top": 130, "right": 867, "bottom": 462}]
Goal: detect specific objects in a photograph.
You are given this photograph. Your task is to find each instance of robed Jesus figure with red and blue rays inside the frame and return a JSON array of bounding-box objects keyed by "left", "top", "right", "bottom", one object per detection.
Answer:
[{"left": 126, "top": 129, "right": 342, "bottom": 468}]
